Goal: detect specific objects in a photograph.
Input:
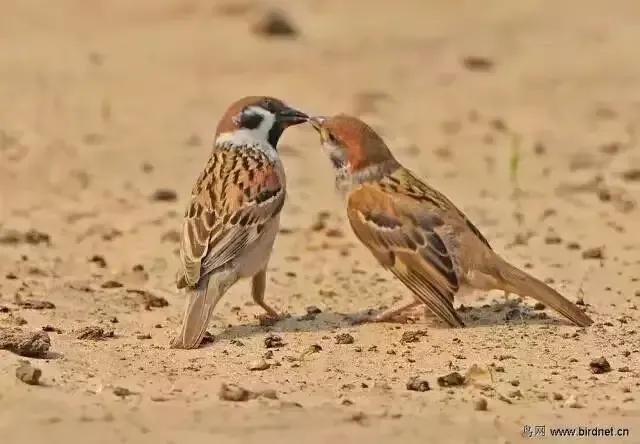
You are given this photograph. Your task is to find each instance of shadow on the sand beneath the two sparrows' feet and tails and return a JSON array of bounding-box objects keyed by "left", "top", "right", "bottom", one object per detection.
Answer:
[{"left": 206, "top": 301, "right": 572, "bottom": 342}]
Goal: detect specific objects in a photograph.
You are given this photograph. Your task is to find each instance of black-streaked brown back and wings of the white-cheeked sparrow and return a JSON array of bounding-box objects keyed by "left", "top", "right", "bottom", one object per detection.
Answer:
[{"left": 178, "top": 149, "right": 285, "bottom": 287}]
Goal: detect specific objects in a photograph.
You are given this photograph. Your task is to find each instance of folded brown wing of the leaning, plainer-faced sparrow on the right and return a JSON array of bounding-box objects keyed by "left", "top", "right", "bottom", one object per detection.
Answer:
[{"left": 348, "top": 185, "right": 464, "bottom": 327}]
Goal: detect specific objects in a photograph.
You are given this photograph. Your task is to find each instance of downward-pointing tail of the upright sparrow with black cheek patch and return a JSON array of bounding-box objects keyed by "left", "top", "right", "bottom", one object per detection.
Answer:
[{"left": 171, "top": 272, "right": 238, "bottom": 348}]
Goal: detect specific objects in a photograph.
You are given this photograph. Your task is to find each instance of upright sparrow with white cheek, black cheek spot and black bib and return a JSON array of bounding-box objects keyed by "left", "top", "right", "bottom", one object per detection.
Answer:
[{"left": 171, "top": 97, "right": 308, "bottom": 348}]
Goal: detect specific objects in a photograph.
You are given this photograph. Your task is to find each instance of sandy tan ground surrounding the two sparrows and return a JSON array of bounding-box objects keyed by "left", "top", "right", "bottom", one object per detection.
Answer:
[{"left": 0, "top": 0, "right": 640, "bottom": 444}]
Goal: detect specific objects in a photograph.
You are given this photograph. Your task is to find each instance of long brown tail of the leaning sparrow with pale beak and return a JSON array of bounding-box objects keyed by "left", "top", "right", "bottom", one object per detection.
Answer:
[{"left": 496, "top": 257, "right": 593, "bottom": 327}]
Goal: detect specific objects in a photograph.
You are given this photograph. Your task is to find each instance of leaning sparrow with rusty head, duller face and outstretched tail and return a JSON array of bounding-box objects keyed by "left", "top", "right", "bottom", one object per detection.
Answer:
[{"left": 309, "top": 114, "right": 593, "bottom": 327}]
